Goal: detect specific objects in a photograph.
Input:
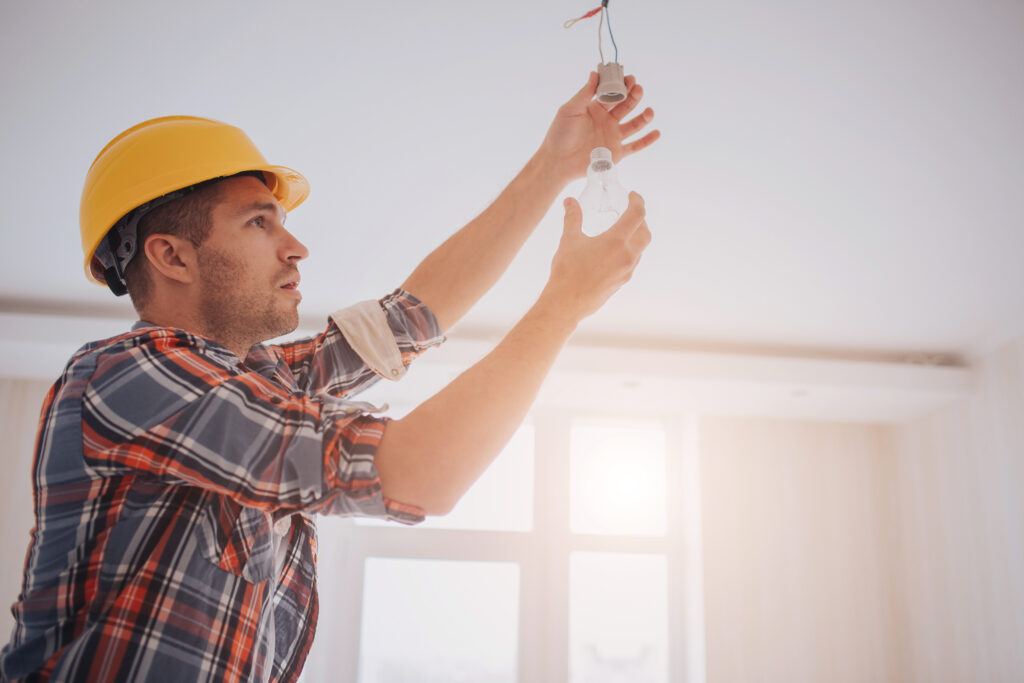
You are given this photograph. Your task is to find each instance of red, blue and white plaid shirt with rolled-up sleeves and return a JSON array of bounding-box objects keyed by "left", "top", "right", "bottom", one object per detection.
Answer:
[{"left": 0, "top": 289, "right": 444, "bottom": 682}]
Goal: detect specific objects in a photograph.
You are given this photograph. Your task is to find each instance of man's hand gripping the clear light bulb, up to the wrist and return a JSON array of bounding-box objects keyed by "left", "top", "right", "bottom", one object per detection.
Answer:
[{"left": 538, "top": 193, "right": 650, "bottom": 323}]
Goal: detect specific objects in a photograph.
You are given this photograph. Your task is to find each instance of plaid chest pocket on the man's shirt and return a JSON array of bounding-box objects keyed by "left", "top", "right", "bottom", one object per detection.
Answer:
[{"left": 199, "top": 496, "right": 274, "bottom": 584}]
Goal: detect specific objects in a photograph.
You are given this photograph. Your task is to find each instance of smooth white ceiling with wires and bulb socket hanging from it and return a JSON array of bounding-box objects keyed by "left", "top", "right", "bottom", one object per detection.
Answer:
[{"left": 0, "top": 0, "right": 1024, "bottom": 362}]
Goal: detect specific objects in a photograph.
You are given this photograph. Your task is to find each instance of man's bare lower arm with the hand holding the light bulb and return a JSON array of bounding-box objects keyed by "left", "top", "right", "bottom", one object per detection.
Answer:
[{"left": 375, "top": 193, "right": 650, "bottom": 515}]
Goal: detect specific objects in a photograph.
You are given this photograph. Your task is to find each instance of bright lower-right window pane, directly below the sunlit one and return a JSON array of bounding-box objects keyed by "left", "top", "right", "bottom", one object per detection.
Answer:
[{"left": 569, "top": 552, "right": 669, "bottom": 683}]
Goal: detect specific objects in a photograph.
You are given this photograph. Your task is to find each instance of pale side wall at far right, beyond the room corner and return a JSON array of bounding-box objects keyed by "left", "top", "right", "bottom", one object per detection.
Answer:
[{"left": 896, "top": 339, "right": 1024, "bottom": 682}]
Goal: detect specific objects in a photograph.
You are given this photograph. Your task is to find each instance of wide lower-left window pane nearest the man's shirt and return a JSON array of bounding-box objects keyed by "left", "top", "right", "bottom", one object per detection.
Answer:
[{"left": 359, "top": 557, "right": 519, "bottom": 683}]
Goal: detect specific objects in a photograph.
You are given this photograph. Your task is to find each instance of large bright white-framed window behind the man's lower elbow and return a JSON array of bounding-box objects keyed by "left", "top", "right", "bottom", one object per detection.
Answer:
[{"left": 304, "top": 413, "right": 702, "bottom": 683}]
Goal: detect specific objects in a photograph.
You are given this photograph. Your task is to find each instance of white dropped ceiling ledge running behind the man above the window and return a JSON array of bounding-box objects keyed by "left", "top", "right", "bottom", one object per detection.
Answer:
[{"left": 0, "top": 302, "right": 975, "bottom": 423}]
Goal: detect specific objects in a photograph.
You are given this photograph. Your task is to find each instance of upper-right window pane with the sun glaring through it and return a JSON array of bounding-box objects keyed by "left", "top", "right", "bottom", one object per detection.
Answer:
[{"left": 569, "top": 421, "right": 665, "bottom": 536}]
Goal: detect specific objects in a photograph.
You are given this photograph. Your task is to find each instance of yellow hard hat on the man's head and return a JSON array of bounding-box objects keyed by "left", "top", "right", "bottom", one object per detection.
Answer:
[{"left": 79, "top": 116, "right": 309, "bottom": 289}]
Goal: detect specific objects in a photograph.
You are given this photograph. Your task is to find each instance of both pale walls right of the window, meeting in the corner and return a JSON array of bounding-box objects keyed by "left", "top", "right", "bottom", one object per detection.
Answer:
[{"left": 699, "top": 340, "right": 1024, "bottom": 683}]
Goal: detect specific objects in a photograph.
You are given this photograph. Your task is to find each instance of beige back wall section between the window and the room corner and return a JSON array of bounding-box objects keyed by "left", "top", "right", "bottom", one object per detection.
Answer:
[{"left": 699, "top": 418, "right": 901, "bottom": 683}]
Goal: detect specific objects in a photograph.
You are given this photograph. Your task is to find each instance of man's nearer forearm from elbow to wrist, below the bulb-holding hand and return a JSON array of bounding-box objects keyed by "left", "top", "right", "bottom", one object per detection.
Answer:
[{"left": 376, "top": 290, "right": 575, "bottom": 514}]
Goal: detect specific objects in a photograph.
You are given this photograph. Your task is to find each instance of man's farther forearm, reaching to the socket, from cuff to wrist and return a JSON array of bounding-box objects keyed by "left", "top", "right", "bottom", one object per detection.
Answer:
[{"left": 401, "top": 152, "right": 565, "bottom": 331}]
